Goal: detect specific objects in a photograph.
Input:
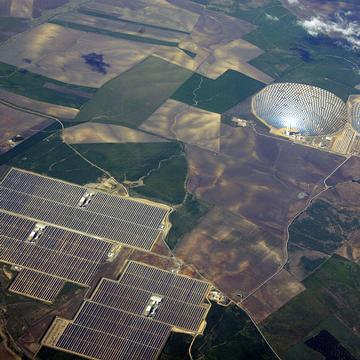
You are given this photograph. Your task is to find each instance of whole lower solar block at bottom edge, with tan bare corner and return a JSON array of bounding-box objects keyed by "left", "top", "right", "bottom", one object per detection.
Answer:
[{"left": 43, "top": 261, "right": 210, "bottom": 360}]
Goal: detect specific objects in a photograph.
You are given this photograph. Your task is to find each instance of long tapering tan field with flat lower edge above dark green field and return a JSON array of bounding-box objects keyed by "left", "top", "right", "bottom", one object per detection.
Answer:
[{"left": 62, "top": 123, "right": 167, "bottom": 144}]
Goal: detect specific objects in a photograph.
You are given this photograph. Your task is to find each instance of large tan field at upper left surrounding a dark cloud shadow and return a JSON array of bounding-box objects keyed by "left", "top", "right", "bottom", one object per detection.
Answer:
[{"left": 0, "top": 24, "right": 154, "bottom": 87}]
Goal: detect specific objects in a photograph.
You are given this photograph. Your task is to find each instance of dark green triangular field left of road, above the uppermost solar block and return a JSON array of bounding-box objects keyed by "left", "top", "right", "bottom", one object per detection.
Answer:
[{"left": 7, "top": 132, "right": 103, "bottom": 185}]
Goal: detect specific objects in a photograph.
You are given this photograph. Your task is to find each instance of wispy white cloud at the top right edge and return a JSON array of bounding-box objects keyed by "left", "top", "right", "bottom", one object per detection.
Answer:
[{"left": 299, "top": 13, "right": 360, "bottom": 50}]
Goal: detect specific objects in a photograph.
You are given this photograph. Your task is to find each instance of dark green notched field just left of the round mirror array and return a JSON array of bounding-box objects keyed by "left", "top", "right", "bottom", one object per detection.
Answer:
[{"left": 172, "top": 70, "right": 265, "bottom": 114}]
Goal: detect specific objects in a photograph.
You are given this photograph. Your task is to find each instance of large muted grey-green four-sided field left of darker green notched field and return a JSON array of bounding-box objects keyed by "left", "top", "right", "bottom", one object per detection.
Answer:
[{"left": 75, "top": 56, "right": 192, "bottom": 128}]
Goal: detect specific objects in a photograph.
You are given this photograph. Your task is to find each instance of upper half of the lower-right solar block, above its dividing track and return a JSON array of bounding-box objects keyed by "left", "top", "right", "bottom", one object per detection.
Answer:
[{"left": 91, "top": 262, "right": 209, "bottom": 332}]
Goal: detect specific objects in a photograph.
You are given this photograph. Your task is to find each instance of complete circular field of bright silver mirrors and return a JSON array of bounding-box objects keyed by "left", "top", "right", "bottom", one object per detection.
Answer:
[{"left": 252, "top": 83, "right": 347, "bottom": 136}]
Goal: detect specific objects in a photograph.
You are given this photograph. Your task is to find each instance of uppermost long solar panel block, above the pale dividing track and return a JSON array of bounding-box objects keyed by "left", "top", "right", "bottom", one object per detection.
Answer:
[{"left": 0, "top": 168, "right": 168, "bottom": 250}]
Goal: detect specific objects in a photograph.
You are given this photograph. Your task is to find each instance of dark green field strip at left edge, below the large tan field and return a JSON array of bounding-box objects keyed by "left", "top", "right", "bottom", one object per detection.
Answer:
[{"left": 0, "top": 63, "right": 97, "bottom": 108}]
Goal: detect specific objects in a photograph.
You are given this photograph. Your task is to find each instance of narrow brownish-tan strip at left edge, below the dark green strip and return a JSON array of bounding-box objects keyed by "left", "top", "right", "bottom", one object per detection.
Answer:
[{"left": 0, "top": 89, "right": 79, "bottom": 120}]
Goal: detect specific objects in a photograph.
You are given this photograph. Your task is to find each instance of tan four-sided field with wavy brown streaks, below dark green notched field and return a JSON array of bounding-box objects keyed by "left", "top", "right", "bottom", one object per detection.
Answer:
[{"left": 140, "top": 100, "right": 221, "bottom": 151}]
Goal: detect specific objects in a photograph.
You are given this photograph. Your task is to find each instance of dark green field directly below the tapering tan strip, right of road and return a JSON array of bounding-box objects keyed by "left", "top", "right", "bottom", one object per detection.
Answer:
[{"left": 73, "top": 142, "right": 186, "bottom": 181}]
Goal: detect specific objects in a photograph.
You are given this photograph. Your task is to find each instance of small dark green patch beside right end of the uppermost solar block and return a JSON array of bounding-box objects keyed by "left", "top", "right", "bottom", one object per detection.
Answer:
[{"left": 165, "top": 193, "right": 210, "bottom": 250}]
